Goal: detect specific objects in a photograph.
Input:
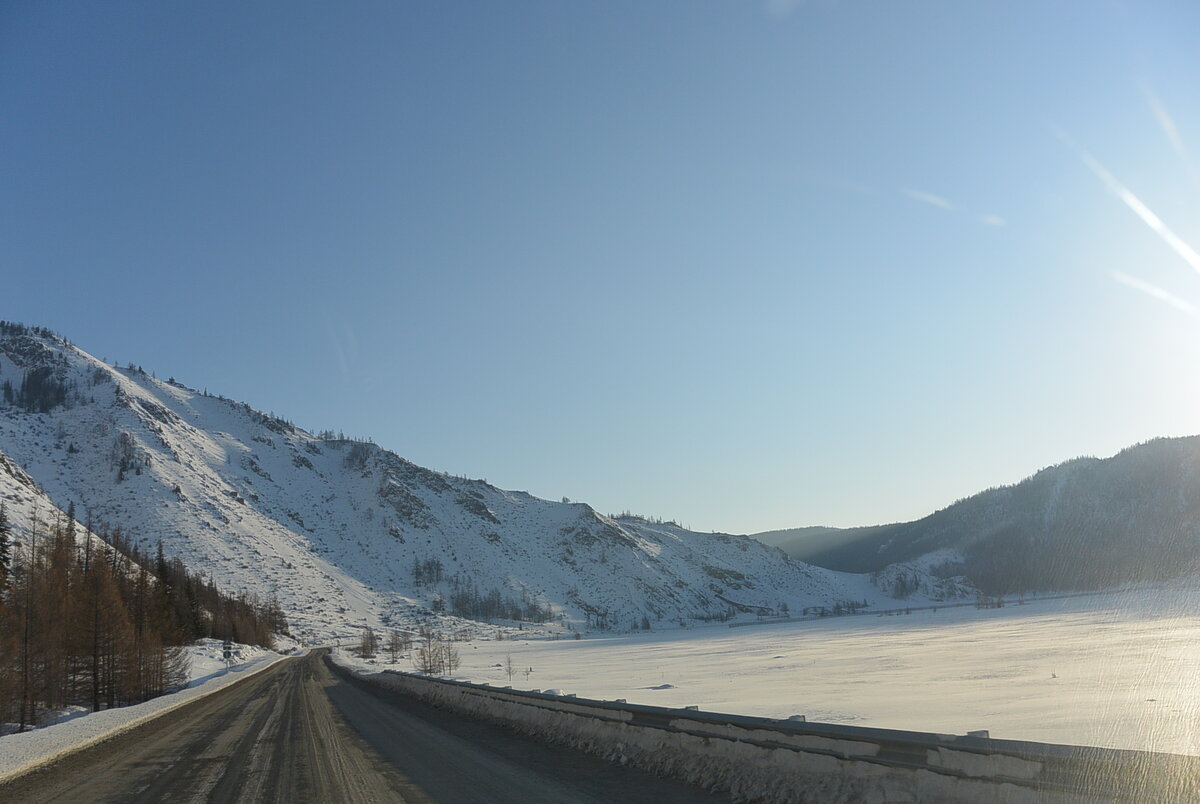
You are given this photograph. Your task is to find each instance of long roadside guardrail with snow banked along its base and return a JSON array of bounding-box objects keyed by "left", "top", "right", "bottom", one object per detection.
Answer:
[{"left": 326, "top": 656, "right": 1200, "bottom": 804}]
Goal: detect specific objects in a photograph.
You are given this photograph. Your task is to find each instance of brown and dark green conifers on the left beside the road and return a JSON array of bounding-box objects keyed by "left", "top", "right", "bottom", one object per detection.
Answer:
[{"left": 0, "top": 502, "right": 287, "bottom": 731}]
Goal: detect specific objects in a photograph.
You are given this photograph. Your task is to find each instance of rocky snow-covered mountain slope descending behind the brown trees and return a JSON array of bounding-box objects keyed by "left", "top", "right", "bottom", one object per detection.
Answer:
[{"left": 0, "top": 324, "right": 902, "bottom": 635}]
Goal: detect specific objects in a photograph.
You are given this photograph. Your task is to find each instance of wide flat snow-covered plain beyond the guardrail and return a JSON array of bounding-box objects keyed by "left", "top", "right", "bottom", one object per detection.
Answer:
[{"left": 355, "top": 584, "right": 1200, "bottom": 754}]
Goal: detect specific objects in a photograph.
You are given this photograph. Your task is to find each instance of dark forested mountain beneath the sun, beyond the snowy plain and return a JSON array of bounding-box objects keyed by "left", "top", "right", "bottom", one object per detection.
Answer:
[{"left": 758, "top": 436, "right": 1200, "bottom": 594}]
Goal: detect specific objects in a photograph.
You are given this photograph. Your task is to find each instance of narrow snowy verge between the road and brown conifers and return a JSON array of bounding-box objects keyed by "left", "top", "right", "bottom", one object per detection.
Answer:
[{"left": 0, "top": 640, "right": 298, "bottom": 781}]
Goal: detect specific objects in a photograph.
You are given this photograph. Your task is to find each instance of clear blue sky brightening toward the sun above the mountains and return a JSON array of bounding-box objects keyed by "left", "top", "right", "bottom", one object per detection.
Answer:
[{"left": 0, "top": 0, "right": 1200, "bottom": 533}]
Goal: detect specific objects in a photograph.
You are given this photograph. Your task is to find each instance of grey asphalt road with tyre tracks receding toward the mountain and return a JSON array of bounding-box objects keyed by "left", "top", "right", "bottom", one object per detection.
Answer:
[{"left": 0, "top": 652, "right": 728, "bottom": 804}]
